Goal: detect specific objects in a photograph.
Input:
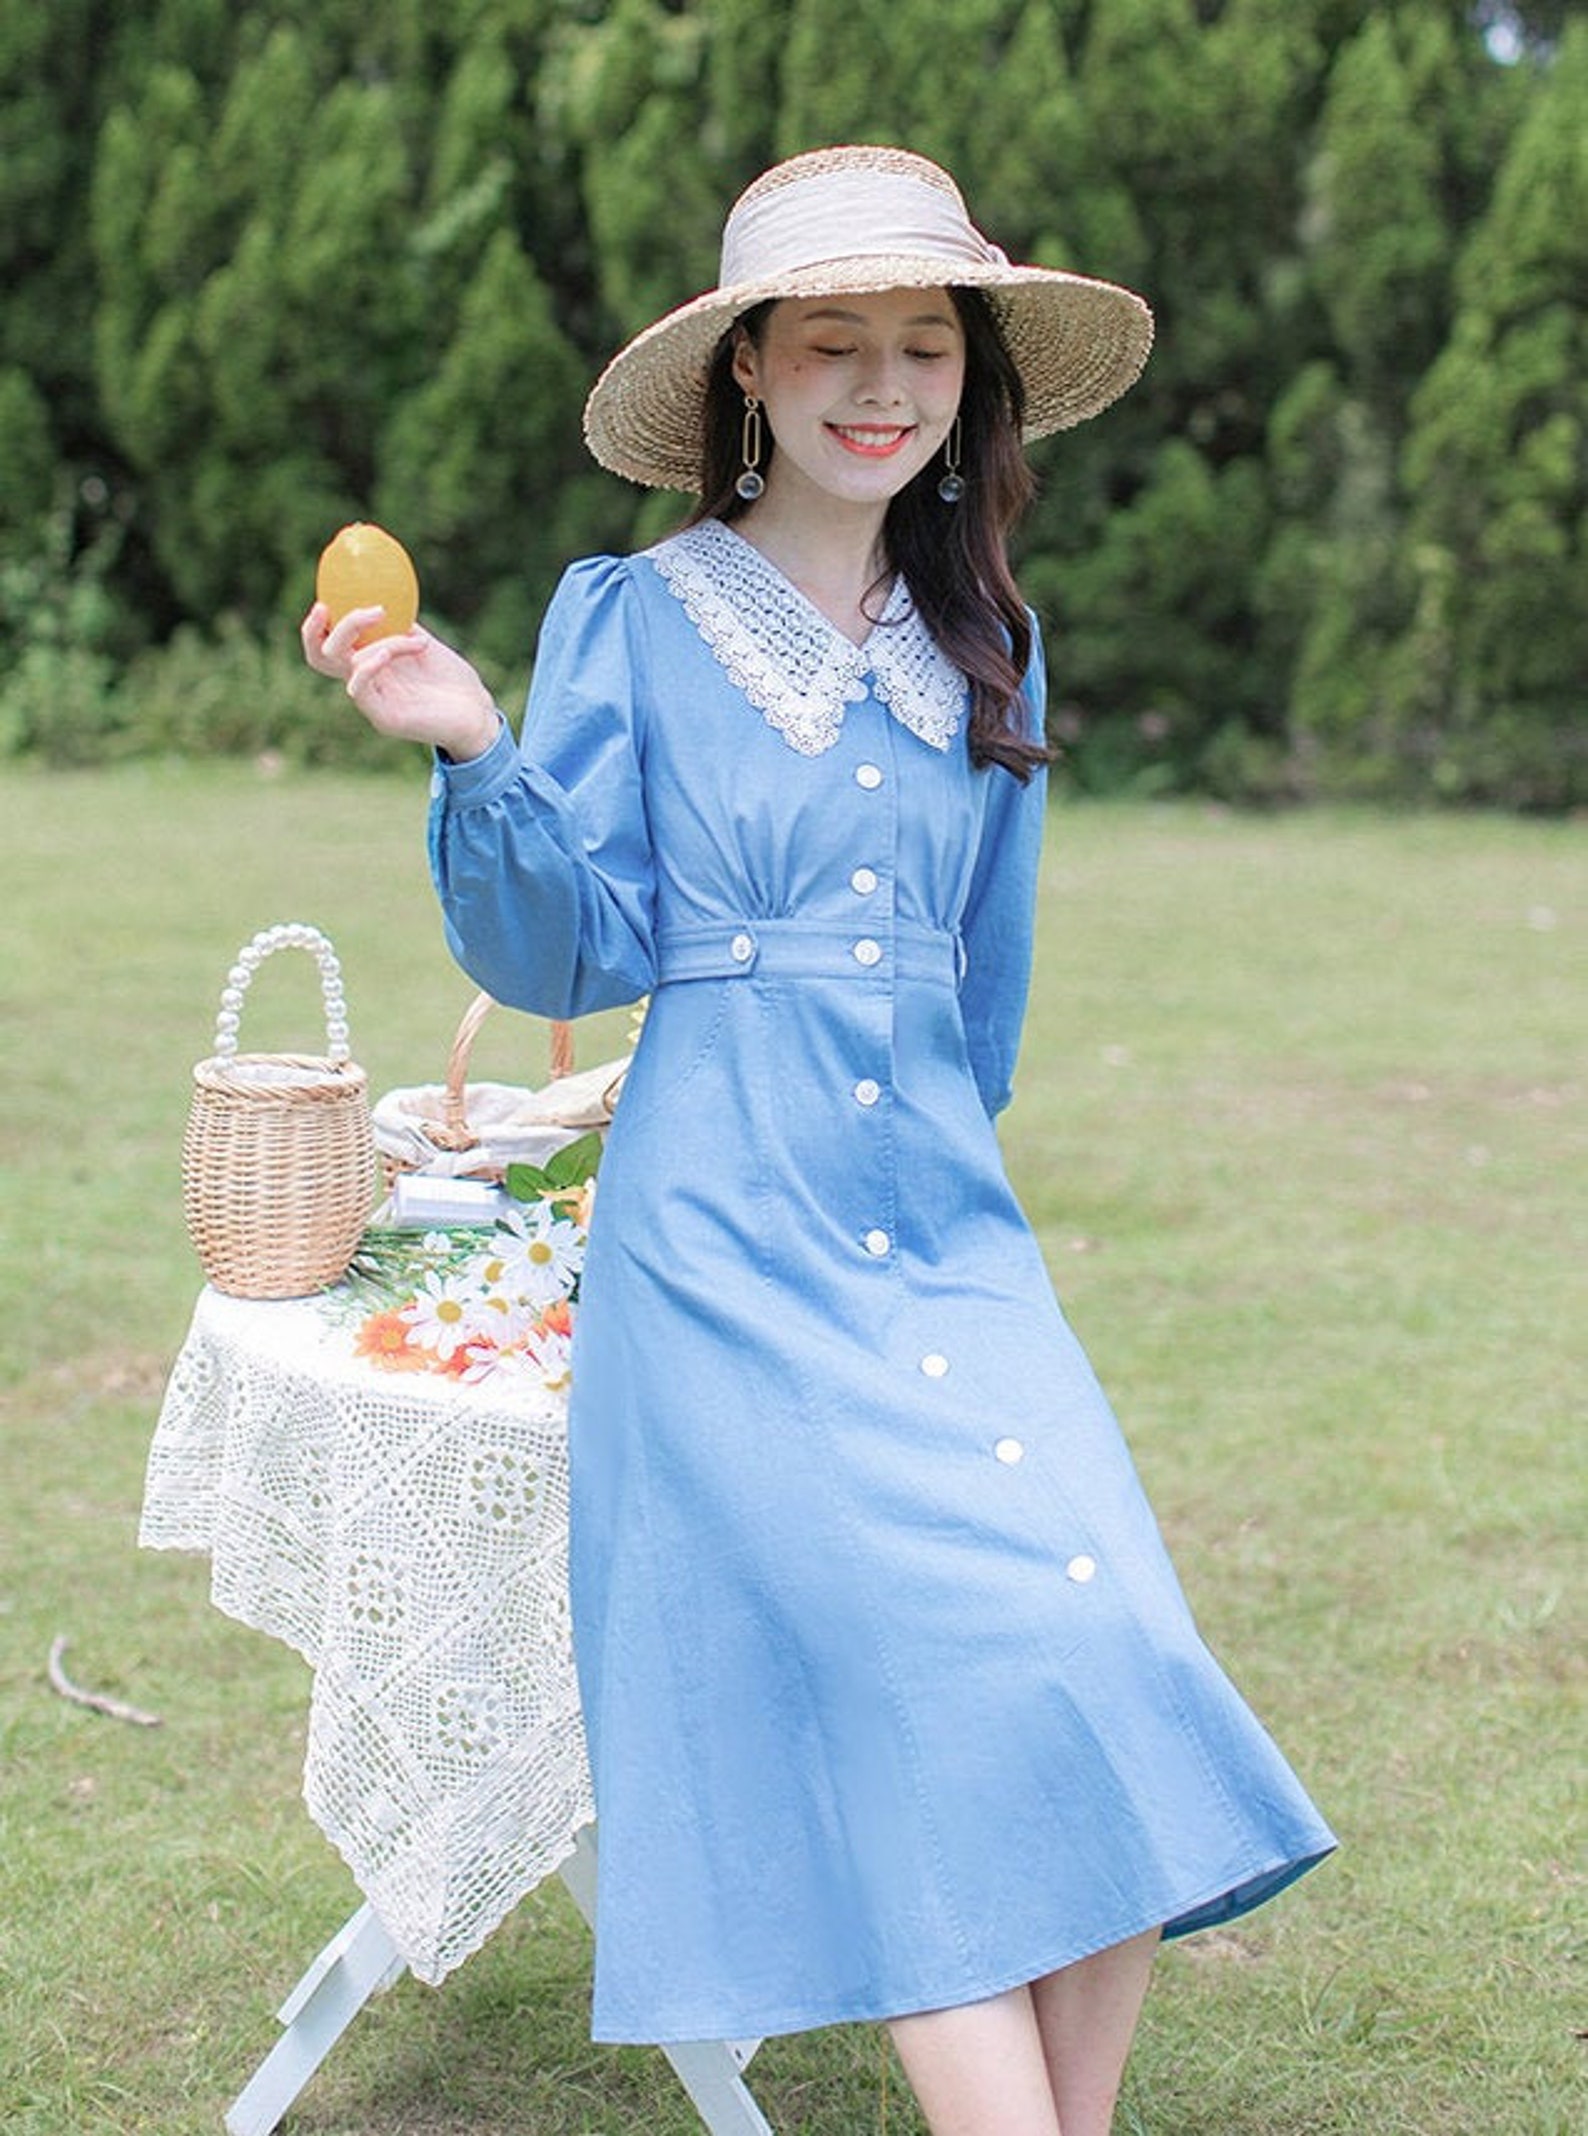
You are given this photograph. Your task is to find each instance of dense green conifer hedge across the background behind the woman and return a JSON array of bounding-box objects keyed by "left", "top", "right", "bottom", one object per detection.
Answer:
[{"left": 0, "top": 0, "right": 1588, "bottom": 810}]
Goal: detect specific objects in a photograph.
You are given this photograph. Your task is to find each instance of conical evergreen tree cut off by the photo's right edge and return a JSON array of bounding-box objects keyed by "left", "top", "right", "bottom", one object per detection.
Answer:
[{"left": 1394, "top": 21, "right": 1588, "bottom": 807}]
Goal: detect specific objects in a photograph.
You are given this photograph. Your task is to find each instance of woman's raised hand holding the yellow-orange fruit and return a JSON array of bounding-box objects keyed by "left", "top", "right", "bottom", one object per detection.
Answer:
[{"left": 299, "top": 600, "right": 502, "bottom": 763}]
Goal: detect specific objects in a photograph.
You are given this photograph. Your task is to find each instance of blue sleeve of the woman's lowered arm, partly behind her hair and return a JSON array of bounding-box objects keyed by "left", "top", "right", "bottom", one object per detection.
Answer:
[{"left": 960, "top": 617, "right": 1047, "bottom": 1117}]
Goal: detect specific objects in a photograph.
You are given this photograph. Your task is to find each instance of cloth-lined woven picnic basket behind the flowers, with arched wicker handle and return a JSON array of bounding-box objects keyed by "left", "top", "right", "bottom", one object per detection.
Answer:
[{"left": 374, "top": 993, "right": 628, "bottom": 1188}]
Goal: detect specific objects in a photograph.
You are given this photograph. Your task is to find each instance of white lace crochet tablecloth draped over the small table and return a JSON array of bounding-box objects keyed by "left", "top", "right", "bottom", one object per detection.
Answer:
[{"left": 139, "top": 1290, "right": 594, "bottom": 1982}]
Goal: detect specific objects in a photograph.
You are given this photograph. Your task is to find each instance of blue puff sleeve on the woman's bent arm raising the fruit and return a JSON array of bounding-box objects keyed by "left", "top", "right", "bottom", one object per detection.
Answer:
[{"left": 430, "top": 557, "right": 656, "bottom": 1017}]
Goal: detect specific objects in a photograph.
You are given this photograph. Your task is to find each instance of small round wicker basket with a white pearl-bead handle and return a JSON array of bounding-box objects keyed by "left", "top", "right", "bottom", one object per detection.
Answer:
[{"left": 182, "top": 925, "right": 374, "bottom": 1299}]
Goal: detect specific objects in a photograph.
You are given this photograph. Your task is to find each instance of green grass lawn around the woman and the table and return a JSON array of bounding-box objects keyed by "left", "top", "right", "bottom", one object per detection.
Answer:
[{"left": 0, "top": 767, "right": 1588, "bottom": 2136}]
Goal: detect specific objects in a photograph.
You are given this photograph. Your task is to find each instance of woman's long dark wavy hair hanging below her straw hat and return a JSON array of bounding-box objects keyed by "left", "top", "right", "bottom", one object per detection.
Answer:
[{"left": 690, "top": 288, "right": 1054, "bottom": 782}]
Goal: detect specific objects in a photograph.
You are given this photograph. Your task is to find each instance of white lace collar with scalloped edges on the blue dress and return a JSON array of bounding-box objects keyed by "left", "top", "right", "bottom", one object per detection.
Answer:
[{"left": 645, "top": 519, "right": 966, "bottom": 756}]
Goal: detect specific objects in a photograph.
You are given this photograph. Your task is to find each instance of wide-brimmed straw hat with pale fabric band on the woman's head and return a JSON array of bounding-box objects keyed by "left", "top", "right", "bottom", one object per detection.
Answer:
[{"left": 583, "top": 147, "right": 1152, "bottom": 489}]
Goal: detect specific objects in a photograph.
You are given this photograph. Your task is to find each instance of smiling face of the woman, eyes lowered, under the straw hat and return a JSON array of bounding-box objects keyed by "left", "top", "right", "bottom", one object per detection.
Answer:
[{"left": 733, "top": 288, "right": 964, "bottom": 504}]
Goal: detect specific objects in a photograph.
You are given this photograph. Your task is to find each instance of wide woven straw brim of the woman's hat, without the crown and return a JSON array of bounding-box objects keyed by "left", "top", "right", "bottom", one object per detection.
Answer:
[{"left": 583, "top": 254, "right": 1152, "bottom": 489}]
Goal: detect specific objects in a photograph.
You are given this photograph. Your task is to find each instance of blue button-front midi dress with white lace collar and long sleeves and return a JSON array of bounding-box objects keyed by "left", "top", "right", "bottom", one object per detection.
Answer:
[{"left": 432, "top": 521, "right": 1334, "bottom": 2042}]
